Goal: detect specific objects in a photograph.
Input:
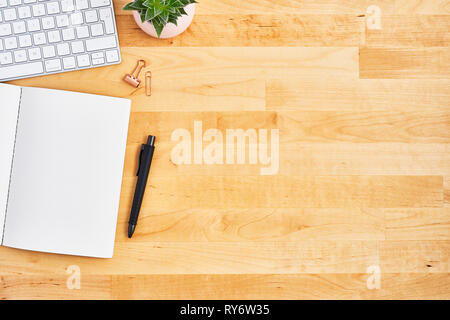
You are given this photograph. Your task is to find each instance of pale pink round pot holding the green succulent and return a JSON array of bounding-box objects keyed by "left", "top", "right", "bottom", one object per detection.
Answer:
[{"left": 133, "top": 3, "right": 195, "bottom": 39}]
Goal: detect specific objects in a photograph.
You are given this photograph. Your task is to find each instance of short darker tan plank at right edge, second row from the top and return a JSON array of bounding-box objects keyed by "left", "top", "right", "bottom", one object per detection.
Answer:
[{"left": 359, "top": 47, "right": 450, "bottom": 79}]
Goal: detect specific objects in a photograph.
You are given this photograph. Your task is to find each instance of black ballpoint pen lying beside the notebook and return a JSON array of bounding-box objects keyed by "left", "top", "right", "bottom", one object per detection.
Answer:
[{"left": 128, "top": 136, "right": 155, "bottom": 238}]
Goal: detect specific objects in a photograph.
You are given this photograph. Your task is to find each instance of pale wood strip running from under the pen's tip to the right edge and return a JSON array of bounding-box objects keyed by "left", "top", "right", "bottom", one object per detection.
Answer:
[{"left": 110, "top": 208, "right": 450, "bottom": 242}]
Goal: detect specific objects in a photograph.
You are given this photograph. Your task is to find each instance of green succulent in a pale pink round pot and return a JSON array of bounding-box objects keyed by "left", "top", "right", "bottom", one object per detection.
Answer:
[{"left": 123, "top": 0, "right": 197, "bottom": 39}]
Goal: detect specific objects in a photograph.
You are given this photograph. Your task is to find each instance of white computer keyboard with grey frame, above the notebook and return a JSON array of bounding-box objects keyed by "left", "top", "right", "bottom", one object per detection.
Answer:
[{"left": 0, "top": 0, "right": 121, "bottom": 81}]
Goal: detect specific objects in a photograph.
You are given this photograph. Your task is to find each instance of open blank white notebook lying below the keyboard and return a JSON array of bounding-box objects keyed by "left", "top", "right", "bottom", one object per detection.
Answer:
[{"left": 0, "top": 84, "right": 131, "bottom": 258}]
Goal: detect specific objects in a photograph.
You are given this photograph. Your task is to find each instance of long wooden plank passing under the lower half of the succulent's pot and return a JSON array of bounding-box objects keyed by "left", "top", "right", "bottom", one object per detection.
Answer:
[{"left": 117, "top": 12, "right": 365, "bottom": 47}]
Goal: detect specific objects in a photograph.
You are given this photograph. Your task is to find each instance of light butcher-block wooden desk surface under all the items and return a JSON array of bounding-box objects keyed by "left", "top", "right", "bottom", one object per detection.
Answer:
[{"left": 0, "top": 0, "right": 450, "bottom": 299}]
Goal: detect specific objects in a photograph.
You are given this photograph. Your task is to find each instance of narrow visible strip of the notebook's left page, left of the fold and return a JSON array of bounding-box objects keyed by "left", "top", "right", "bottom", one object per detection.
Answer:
[{"left": 0, "top": 84, "right": 21, "bottom": 243}]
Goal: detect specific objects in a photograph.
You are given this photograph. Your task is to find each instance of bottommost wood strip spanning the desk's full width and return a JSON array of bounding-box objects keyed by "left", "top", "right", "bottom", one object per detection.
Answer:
[{"left": 0, "top": 273, "right": 450, "bottom": 300}]
